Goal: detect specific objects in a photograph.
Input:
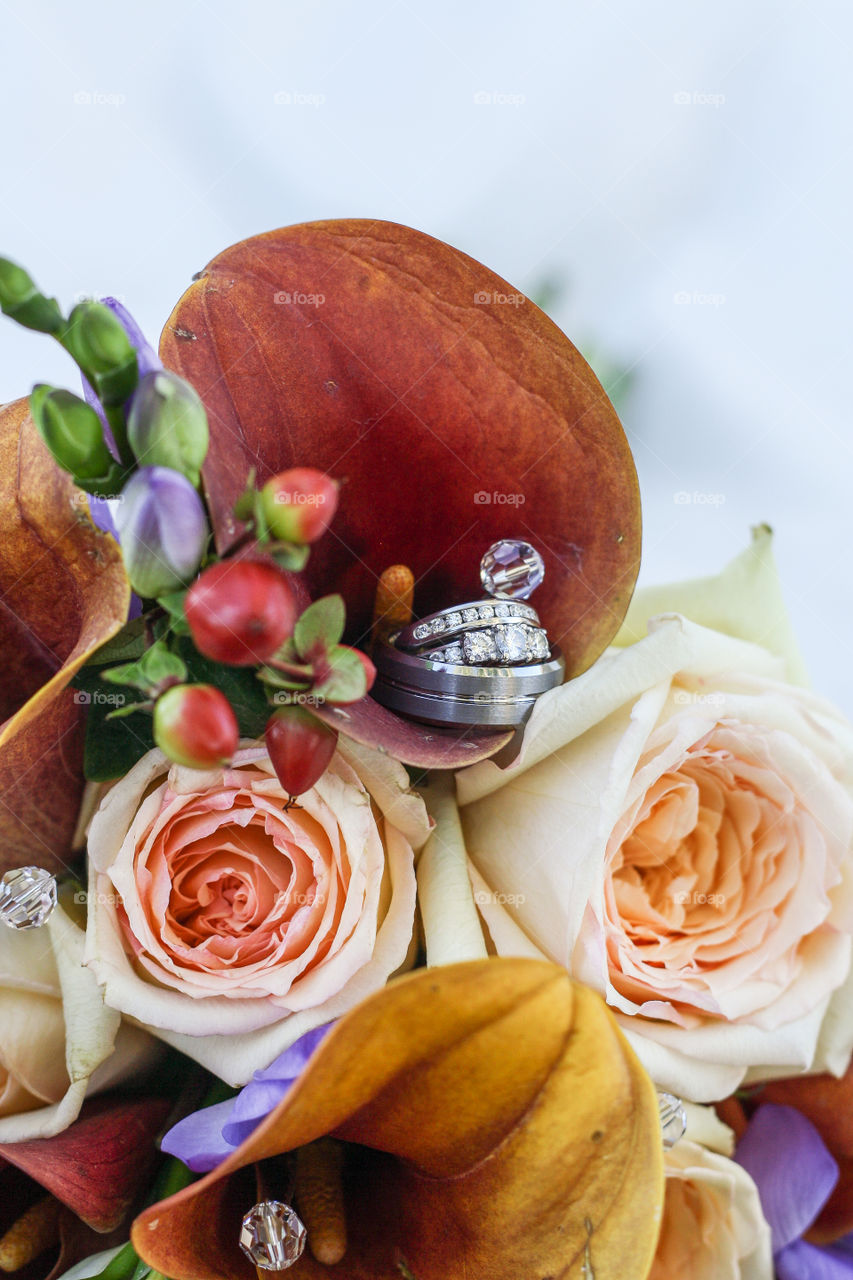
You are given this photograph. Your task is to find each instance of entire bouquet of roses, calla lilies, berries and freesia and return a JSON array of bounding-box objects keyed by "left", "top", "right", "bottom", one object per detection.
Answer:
[{"left": 0, "top": 220, "right": 853, "bottom": 1280}]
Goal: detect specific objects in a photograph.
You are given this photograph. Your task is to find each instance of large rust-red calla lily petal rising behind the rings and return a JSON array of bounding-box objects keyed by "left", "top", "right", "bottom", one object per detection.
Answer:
[{"left": 160, "top": 219, "right": 640, "bottom": 675}]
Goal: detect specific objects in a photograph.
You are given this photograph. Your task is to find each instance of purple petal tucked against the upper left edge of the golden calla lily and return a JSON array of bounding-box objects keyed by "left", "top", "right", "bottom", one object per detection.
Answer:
[{"left": 160, "top": 1023, "right": 334, "bottom": 1174}]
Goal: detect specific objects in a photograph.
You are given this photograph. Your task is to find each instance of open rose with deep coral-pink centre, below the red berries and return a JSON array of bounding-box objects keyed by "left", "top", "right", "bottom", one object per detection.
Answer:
[{"left": 86, "top": 742, "right": 429, "bottom": 1084}]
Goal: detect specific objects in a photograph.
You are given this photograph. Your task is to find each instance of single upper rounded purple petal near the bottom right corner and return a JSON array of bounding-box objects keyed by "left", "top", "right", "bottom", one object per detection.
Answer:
[{"left": 735, "top": 1103, "right": 838, "bottom": 1253}]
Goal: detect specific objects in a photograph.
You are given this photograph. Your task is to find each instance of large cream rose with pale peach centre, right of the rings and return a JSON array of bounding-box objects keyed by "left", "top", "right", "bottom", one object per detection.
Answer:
[{"left": 457, "top": 530, "right": 853, "bottom": 1101}]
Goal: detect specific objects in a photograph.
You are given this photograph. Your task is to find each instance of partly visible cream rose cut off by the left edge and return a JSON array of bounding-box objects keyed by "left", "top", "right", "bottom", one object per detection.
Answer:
[{"left": 0, "top": 899, "right": 156, "bottom": 1142}]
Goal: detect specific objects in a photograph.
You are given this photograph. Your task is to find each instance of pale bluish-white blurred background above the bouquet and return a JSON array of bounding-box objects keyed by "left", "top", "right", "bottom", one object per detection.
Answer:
[{"left": 0, "top": 0, "right": 853, "bottom": 714}]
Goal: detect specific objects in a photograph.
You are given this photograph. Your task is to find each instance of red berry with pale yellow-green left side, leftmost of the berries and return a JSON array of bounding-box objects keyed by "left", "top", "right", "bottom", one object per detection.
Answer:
[{"left": 154, "top": 685, "right": 240, "bottom": 769}]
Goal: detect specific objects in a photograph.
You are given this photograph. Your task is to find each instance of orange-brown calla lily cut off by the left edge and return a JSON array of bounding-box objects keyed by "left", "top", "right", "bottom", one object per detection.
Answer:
[{"left": 0, "top": 399, "right": 129, "bottom": 872}]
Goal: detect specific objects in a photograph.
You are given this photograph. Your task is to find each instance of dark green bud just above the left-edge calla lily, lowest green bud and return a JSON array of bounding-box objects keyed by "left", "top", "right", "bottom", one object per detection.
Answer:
[{"left": 29, "top": 384, "right": 124, "bottom": 495}]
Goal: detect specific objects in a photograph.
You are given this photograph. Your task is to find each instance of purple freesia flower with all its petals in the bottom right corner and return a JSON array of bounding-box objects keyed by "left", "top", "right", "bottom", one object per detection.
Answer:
[{"left": 735, "top": 1103, "right": 853, "bottom": 1280}]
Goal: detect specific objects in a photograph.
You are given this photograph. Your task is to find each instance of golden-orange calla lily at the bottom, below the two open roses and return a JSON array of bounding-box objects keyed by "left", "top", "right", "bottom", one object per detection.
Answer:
[{"left": 132, "top": 959, "right": 663, "bottom": 1280}]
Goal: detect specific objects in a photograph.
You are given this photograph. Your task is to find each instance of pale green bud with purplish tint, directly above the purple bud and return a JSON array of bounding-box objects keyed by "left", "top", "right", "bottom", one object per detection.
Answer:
[{"left": 127, "top": 369, "right": 210, "bottom": 488}]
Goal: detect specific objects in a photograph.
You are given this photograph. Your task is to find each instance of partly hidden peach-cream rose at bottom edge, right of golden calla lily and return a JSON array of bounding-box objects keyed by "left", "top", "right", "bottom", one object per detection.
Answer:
[{"left": 648, "top": 1107, "right": 774, "bottom": 1280}]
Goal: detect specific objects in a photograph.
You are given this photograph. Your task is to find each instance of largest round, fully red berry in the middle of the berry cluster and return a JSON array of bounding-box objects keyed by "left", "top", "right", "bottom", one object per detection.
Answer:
[{"left": 183, "top": 561, "right": 296, "bottom": 667}]
